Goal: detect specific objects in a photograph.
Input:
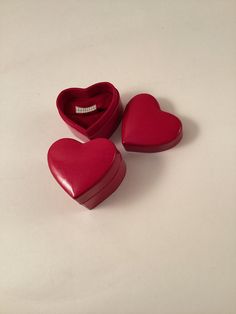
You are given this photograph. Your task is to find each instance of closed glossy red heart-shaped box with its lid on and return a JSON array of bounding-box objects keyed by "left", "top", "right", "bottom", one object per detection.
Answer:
[{"left": 48, "top": 138, "right": 126, "bottom": 209}]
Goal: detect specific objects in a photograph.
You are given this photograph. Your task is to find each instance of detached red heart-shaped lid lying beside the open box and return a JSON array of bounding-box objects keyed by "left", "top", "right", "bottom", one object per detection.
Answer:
[{"left": 122, "top": 94, "right": 182, "bottom": 152}]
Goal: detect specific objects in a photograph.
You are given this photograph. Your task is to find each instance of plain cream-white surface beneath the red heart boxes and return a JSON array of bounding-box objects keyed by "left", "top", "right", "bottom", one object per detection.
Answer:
[{"left": 0, "top": 0, "right": 236, "bottom": 314}]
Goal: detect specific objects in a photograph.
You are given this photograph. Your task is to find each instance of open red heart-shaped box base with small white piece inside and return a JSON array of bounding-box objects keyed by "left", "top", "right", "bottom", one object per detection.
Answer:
[{"left": 56, "top": 82, "right": 122, "bottom": 142}]
